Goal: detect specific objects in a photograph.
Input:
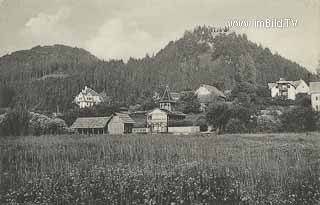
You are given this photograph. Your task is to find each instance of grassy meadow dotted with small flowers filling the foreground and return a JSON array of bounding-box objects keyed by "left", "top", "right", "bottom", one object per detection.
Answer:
[{"left": 0, "top": 133, "right": 320, "bottom": 204}]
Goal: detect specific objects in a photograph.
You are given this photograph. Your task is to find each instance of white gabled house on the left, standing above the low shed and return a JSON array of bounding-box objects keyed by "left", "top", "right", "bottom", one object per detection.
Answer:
[{"left": 74, "top": 86, "right": 104, "bottom": 108}]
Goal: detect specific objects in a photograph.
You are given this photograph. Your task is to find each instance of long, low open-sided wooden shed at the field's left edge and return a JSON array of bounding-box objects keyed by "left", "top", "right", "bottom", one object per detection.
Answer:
[{"left": 71, "top": 117, "right": 111, "bottom": 134}]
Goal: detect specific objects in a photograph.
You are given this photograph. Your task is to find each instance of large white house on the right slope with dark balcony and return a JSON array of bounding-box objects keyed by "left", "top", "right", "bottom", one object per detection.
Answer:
[{"left": 268, "top": 78, "right": 309, "bottom": 100}]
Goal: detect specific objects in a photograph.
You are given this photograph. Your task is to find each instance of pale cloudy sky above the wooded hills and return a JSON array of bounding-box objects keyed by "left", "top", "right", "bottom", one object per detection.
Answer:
[{"left": 0, "top": 0, "right": 320, "bottom": 71}]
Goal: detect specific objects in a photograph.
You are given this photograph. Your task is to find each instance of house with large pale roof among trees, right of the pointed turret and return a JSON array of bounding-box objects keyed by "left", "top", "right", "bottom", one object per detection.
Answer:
[{"left": 195, "top": 84, "right": 226, "bottom": 111}]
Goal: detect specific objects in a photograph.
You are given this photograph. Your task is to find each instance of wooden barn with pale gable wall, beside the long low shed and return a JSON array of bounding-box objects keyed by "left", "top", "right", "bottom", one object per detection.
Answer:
[{"left": 108, "top": 113, "right": 135, "bottom": 134}]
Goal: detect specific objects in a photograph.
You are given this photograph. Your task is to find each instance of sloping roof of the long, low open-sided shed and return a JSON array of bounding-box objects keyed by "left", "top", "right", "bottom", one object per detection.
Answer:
[{"left": 71, "top": 117, "right": 111, "bottom": 129}]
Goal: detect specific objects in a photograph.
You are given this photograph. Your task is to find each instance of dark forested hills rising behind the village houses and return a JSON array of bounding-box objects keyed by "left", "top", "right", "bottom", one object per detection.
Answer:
[{"left": 0, "top": 26, "right": 311, "bottom": 111}]
